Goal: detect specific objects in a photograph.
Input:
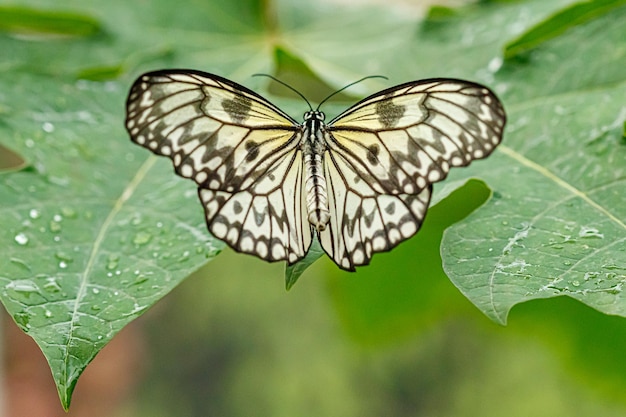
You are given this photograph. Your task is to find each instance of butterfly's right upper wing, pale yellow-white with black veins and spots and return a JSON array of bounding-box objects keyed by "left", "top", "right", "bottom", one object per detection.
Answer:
[{"left": 328, "top": 79, "right": 506, "bottom": 194}]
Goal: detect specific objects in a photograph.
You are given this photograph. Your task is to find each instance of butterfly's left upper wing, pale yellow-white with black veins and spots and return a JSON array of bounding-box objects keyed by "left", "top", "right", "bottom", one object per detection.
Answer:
[{"left": 126, "top": 70, "right": 300, "bottom": 191}]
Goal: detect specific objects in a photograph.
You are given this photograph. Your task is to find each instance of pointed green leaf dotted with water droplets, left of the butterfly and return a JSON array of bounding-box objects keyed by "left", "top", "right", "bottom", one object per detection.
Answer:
[{"left": 0, "top": 75, "right": 223, "bottom": 407}]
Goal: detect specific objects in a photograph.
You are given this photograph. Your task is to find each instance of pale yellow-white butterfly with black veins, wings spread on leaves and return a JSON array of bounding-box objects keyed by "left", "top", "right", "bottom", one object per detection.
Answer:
[{"left": 126, "top": 70, "right": 506, "bottom": 271}]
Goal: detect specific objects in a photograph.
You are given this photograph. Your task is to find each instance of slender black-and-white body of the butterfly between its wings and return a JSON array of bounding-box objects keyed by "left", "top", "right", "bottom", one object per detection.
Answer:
[{"left": 301, "top": 110, "right": 330, "bottom": 231}]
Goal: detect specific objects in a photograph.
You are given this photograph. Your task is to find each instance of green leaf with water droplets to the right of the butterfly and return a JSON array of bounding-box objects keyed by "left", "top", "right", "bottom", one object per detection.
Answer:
[{"left": 442, "top": 1, "right": 626, "bottom": 323}]
